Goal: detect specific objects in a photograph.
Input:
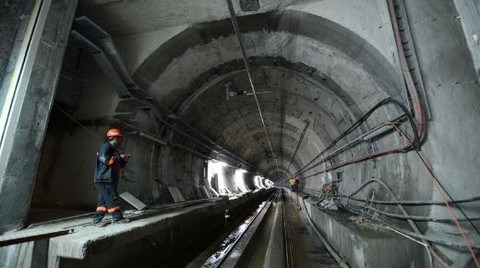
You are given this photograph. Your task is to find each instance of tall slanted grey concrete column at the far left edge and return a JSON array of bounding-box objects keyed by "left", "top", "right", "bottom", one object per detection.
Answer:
[{"left": 0, "top": 0, "right": 77, "bottom": 233}]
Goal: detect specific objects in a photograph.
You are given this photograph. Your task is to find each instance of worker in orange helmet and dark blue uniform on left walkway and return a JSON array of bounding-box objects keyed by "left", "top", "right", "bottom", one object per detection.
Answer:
[{"left": 93, "top": 128, "right": 130, "bottom": 227}]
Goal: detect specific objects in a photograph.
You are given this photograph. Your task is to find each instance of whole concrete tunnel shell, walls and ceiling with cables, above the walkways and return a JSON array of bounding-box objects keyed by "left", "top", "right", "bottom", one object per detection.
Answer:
[{"left": 0, "top": 0, "right": 480, "bottom": 267}]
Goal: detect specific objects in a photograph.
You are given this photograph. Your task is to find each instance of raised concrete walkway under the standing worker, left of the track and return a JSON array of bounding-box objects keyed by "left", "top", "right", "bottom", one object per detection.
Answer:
[{"left": 0, "top": 191, "right": 274, "bottom": 267}]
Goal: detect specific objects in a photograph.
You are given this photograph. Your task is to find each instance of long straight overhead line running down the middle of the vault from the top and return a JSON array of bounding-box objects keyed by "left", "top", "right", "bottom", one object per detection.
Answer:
[{"left": 226, "top": 0, "right": 278, "bottom": 169}]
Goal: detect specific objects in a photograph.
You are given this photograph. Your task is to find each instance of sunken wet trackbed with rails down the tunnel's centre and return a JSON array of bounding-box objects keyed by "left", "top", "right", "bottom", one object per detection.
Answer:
[{"left": 187, "top": 189, "right": 339, "bottom": 268}]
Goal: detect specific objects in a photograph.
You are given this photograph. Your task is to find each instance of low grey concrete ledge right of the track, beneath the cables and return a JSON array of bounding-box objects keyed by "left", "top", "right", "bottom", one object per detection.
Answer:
[{"left": 303, "top": 196, "right": 428, "bottom": 267}]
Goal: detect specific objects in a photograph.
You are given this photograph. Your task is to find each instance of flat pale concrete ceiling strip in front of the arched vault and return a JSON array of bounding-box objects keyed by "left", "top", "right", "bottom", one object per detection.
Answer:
[{"left": 79, "top": 0, "right": 326, "bottom": 35}]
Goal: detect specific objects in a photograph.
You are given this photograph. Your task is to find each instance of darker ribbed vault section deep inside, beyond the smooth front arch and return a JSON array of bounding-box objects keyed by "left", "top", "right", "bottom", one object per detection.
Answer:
[{"left": 174, "top": 66, "right": 350, "bottom": 170}]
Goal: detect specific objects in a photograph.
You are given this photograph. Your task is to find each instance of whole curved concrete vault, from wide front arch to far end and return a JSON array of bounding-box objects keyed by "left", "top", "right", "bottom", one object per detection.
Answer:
[{"left": 129, "top": 11, "right": 401, "bottom": 180}]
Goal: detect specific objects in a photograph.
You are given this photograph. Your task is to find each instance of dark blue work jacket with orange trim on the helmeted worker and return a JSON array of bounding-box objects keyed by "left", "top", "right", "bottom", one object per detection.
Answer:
[{"left": 93, "top": 141, "right": 127, "bottom": 184}]
